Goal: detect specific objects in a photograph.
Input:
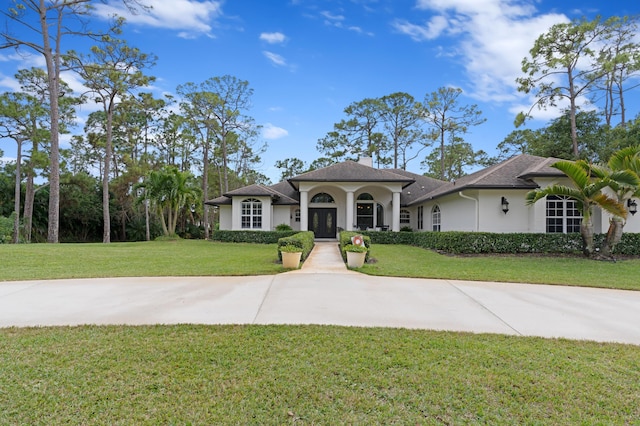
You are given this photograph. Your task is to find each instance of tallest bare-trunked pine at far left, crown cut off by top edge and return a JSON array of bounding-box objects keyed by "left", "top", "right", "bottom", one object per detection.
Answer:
[{"left": 0, "top": 0, "right": 144, "bottom": 243}]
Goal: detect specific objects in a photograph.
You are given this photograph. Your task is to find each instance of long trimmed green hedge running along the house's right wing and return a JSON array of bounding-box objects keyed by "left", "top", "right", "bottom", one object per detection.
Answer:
[{"left": 362, "top": 231, "right": 640, "bottom": 256}]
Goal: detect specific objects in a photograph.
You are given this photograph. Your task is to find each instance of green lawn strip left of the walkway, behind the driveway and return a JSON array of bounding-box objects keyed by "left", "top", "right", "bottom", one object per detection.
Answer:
[{"left": 0, "top": 240, "right": 284, "bottom": 281}]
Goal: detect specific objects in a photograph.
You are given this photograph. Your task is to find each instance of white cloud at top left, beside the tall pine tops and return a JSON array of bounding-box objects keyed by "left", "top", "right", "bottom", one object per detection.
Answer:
[{"left": 95, "top": 0, "right": 222, "bottom": 38}]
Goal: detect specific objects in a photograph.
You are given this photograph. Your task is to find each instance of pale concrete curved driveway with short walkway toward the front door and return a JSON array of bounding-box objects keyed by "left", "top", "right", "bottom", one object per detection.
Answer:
[{"left": 0, "top": 243, "right": 640, "bottom": 345}]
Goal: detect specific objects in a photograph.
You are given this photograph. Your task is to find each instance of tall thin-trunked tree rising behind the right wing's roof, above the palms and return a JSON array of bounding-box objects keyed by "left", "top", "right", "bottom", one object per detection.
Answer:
[{"left": 515, "top": 17, "right": 604, "bottom": 159}]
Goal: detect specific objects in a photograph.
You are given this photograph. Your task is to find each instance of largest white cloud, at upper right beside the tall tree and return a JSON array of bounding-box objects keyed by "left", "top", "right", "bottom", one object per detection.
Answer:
[{"left": 396, "top": 0, "right": 568, "bottom": 102}]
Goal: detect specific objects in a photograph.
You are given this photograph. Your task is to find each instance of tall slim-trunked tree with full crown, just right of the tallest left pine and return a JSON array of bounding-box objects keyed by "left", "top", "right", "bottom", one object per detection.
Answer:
[{"left": 64, "top": 33, "right": 155, "bottom": 243}]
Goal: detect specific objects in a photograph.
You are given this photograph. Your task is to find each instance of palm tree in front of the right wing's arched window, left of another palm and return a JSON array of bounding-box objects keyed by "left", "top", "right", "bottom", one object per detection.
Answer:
[{"left": 526, "top": 160, "right": 627, "bottom": 256}]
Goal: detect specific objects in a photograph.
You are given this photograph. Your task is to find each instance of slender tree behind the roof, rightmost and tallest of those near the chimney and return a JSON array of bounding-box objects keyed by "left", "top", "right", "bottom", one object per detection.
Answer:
[{"left": 422, "top": 87, "right": 486, "bottom": 180}]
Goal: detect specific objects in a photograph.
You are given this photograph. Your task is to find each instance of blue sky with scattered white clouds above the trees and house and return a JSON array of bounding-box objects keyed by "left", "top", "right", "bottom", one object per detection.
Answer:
[{"left": 0, "top": 0, "right": 640, "bottom": 183}]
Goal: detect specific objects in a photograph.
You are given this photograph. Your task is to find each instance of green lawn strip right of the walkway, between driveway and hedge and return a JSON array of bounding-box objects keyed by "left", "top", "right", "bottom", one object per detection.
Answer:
[{"left": 358, "top": 244, "right": 640, "bottom": 290}]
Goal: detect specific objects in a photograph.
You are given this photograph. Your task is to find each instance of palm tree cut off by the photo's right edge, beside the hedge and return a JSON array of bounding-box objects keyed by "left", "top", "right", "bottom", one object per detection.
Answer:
[{"left": 593, "top": 145, "right": 640, "bottom": 257}]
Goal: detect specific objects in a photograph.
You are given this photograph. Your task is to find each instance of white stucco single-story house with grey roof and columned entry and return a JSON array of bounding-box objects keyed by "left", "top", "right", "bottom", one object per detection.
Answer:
[{"left": 207, "top": 155, "right": 640, "bottom": 238}]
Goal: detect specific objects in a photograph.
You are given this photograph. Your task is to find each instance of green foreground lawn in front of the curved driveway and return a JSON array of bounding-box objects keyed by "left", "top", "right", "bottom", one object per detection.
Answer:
[{"left": 0, "top": 325, "right": 640, "bottom": 425}]
